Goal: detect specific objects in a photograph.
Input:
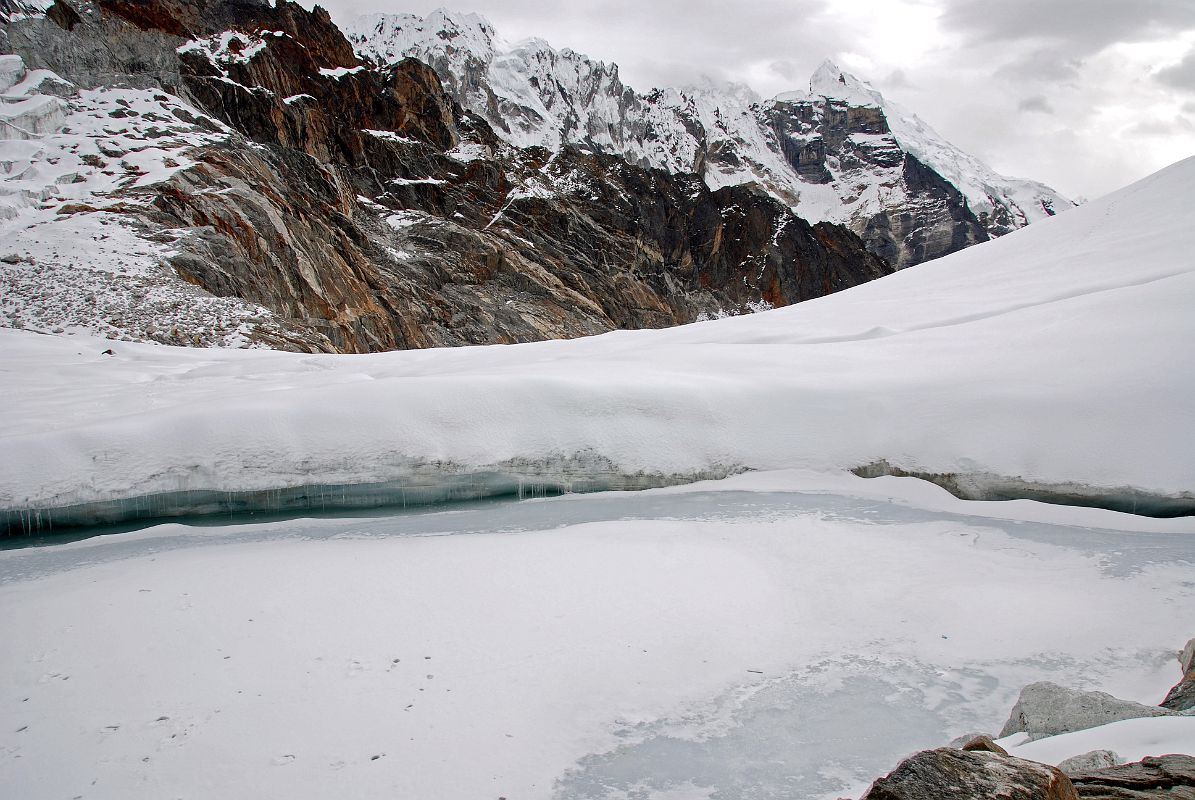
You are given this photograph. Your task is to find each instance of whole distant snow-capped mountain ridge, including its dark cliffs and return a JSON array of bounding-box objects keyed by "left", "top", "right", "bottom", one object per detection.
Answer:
[{"left": 345, "top": 10, "right": 1072, "bottom": 267}]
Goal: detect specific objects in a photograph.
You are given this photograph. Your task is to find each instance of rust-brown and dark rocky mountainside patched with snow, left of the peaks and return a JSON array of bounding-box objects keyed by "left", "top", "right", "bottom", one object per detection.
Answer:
[{"left": 0, "top": 0, "right": 891, "bottom": 352}]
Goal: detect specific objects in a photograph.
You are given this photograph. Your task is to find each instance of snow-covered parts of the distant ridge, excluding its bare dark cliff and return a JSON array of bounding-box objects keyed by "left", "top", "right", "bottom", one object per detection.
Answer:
[{"left": 341, "top": 10, "right": 1072, "bottom": 246}]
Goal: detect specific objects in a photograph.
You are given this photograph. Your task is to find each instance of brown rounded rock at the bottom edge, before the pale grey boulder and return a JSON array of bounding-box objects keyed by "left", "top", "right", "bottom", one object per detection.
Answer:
[{"left": 863, "top": 747, "right": 1079, "bottom": 800}]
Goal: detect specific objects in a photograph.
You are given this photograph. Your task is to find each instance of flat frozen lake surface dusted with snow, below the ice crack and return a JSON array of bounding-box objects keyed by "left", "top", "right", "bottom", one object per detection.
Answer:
[{"left": 7, "top": 472, "right": 1195, "bottom": 800}]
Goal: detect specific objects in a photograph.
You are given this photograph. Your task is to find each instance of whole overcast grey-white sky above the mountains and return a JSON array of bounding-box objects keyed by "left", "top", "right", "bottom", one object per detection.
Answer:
[{"left": 304, "top": 0, "right": 1195, "bottom": 197}]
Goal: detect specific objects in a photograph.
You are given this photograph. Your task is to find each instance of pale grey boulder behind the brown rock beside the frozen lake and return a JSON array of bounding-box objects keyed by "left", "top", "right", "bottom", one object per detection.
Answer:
[{"left": 999, "top": 682, "right": 1171, "bottom": 739}]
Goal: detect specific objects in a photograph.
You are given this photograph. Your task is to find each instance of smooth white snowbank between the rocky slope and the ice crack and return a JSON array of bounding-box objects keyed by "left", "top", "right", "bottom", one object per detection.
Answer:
[{"left": 0, "top": 153, "right": 1195, "bottom": 508}]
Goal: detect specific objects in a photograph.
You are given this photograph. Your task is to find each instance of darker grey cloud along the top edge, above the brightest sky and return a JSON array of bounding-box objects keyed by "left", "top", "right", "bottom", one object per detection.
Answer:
[{"left": 940, "top": 0, "right": 1195, "bottom": 54}]
